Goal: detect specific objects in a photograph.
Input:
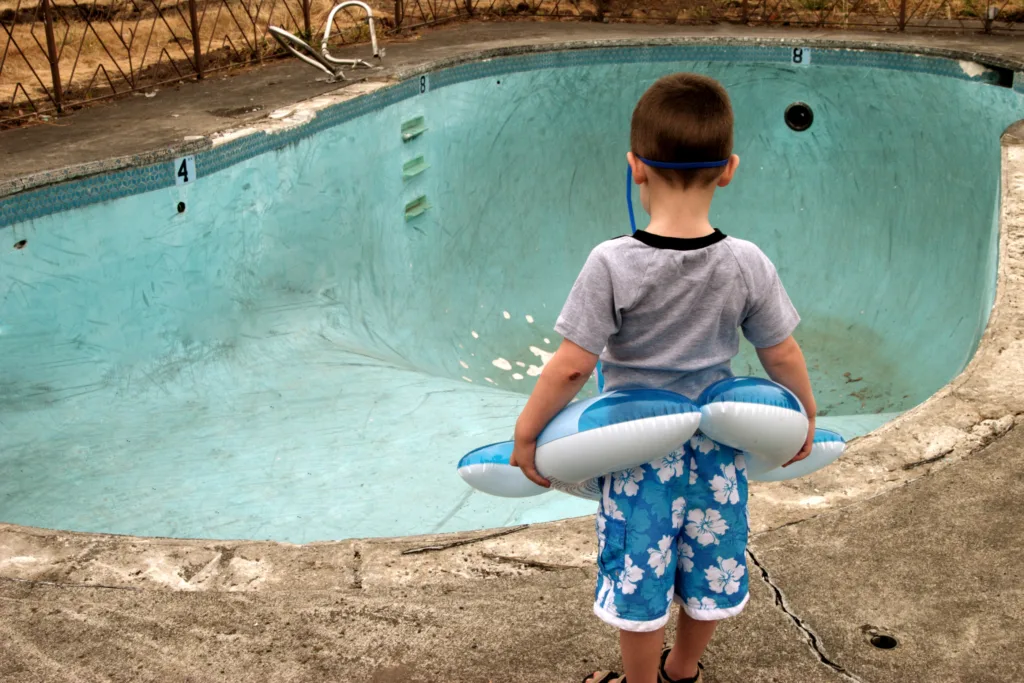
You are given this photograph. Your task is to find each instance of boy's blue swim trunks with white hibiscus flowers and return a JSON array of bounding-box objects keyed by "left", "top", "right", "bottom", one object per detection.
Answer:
[{"left": 594, "top": 433, "right": 749, "bottom": 631}]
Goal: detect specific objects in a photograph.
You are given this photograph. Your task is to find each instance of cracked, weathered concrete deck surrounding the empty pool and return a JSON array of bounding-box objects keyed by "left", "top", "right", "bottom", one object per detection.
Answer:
[{"left": 0, "top": 23, "right": 1024, "bottom": 682}]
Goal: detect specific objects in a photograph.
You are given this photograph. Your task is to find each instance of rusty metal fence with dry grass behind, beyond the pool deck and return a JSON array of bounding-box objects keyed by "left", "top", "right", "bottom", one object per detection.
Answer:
[{"left": 0, "top": 0, "right": 1024, "bottom": 125}]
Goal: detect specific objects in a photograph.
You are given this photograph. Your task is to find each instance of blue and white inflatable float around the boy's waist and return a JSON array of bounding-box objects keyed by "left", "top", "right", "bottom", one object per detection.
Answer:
[{"left": 458, "top": 377, "right": 846, "bottom": 499}]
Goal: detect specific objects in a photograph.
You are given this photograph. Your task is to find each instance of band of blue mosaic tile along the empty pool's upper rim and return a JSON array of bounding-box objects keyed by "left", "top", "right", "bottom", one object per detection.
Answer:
[{"left": 0, "top": 45, "right": 1024, "bottom": 227}]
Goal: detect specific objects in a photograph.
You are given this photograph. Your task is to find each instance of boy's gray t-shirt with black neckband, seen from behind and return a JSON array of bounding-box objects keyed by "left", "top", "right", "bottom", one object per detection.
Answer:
[{"left": 555, "top": 230, "right": 800, "bottom": 398}]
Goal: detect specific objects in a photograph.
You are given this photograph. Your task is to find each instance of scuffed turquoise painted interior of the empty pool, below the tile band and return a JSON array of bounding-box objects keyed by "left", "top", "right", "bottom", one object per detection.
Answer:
[{"left": 0, "top": 48, "right": 1021, "bottom": 542}]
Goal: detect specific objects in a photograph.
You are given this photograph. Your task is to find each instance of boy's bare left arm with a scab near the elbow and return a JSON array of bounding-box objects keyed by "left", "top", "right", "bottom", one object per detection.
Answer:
[{"left": 509, "top": 339, "right": 598, "bottom": 486}]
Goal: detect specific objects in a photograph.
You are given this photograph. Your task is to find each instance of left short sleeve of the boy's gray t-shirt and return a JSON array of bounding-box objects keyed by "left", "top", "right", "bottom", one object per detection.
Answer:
[{"left": 555, "top": 247, "right": 623, "bottom": 354}]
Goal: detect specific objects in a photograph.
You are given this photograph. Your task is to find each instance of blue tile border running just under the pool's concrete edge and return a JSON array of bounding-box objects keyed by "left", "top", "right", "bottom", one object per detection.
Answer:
[{"left": 0, "top": 41, "right": 1024, "bottom": 228}]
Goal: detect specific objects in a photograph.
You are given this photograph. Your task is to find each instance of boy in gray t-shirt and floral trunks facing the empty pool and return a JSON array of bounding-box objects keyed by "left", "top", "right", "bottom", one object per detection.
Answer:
[{"left": 512, "top": 74, "right": 816, "bottom": 683}]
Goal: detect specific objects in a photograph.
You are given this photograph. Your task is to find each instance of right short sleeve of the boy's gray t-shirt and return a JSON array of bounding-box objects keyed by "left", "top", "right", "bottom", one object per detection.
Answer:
[{"left": 741, "top": 250, "right": 800, "bottom": 348}]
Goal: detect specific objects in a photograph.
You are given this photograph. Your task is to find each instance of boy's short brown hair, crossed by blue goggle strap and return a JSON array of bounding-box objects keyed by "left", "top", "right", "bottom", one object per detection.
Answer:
[{"left": 630, "top": 74, "right": 732, "bottom": 187}]
